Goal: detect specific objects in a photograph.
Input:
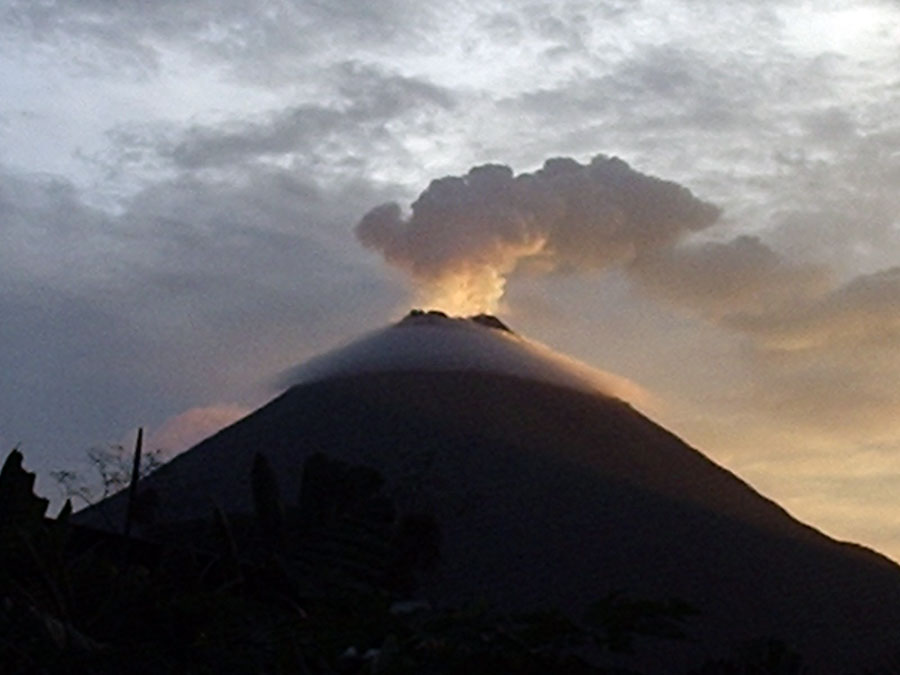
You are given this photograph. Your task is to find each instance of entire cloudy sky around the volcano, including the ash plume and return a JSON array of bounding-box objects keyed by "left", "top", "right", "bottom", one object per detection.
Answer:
[{"left": 0, "top": 0, "right": 900, "bottom": 560}]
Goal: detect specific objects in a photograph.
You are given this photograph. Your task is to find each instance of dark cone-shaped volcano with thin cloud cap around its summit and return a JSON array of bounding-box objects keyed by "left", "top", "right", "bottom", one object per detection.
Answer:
[{"left": 81, "top": 312, "right": 900, "bottom": 673}]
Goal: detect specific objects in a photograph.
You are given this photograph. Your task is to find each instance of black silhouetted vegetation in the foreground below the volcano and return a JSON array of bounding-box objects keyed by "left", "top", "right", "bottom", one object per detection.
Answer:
[{"left": 0, "top": 450, "right": 806, "bottom": 675}]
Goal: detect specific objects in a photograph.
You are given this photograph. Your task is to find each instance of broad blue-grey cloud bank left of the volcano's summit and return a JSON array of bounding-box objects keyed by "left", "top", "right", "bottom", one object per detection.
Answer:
[{"left": 0, "top": 164, "right": 403, "bottom": 480}]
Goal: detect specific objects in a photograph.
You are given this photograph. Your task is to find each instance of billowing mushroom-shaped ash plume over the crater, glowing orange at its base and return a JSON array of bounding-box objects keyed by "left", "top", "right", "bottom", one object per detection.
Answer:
[{"left": 356, "top": 155, "right": 719, "bottom": 314}]
